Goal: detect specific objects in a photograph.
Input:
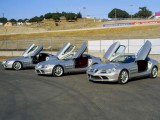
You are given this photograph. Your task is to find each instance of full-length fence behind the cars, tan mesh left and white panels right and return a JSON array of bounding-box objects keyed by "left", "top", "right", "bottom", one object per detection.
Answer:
[{"left": 0, "top": 37, "right": 160, "bottom": 54}]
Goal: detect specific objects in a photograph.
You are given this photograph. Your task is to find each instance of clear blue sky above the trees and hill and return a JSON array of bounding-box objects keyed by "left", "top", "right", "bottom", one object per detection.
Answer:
[{"left": 0, "top": 0, "right": 160, "bottom": 20}]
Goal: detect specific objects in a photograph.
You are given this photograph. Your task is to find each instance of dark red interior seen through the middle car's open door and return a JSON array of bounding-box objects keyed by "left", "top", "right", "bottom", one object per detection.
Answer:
[{"left": 75, "top": 56, "right": 88, "bottom": 68}]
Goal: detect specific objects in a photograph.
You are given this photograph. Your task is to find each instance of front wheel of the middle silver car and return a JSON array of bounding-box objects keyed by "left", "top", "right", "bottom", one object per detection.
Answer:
[{"left": 53, "top": 65, "right": 64, "bottom": 77}]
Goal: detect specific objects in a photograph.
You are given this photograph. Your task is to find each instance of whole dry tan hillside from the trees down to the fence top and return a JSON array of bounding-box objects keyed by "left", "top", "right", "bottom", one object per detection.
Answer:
[{"left": 0, "top": 19, "right": 160, "bottom": 40}]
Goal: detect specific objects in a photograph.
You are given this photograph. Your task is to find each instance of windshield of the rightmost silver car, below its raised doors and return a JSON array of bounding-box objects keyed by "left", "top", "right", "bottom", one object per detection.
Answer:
[{"left": 112, "top": 55, "right": 136, "bottom": 63}]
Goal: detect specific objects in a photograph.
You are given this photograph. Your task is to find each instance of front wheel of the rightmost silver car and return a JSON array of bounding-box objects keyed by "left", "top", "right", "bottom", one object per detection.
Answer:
[{"left": 118, "top": 70, "right": 129, "bottom": 84}]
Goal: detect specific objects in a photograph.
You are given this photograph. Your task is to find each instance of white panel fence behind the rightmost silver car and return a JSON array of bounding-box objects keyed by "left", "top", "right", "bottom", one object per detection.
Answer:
[{"left": 88, "top": 38, "right": 160, "bottom": 54}]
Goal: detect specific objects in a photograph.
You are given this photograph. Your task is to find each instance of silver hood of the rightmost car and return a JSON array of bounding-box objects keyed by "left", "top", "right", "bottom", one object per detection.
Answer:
[{"left": 92, "top": 62, "right": 121, "bottom": 70}]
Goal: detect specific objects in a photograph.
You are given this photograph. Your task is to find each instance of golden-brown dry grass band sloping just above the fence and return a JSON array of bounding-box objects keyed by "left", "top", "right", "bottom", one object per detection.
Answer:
[{"left": 0, "top": 24, "right": 160, "bottom": 40}]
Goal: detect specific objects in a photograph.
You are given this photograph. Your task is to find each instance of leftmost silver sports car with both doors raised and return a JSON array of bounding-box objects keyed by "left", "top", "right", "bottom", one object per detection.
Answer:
[{"left": 2, "top": 44, "right": 54, "bottom": 70}]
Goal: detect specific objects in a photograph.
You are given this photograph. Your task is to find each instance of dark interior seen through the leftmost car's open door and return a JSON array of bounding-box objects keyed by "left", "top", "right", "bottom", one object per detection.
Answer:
[{"left": 33, "top": 53, "right": 48, "bottom": 64}]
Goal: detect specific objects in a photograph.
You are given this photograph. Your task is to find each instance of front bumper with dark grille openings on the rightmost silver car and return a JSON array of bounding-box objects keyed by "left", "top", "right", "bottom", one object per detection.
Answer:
[{"left": 87, "top": 71, "right": 119, "bottom": 82}]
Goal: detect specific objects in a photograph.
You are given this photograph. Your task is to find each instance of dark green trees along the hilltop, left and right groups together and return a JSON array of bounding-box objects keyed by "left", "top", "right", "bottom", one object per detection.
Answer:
[{"left": 0, "top": 7, "right": 155, "bottom": 23}]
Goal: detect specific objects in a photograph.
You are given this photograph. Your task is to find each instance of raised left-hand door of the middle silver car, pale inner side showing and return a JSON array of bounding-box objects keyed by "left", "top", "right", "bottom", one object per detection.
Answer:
[{"left": 56, "top": 43, "right": 75, "bottom": 59}]
